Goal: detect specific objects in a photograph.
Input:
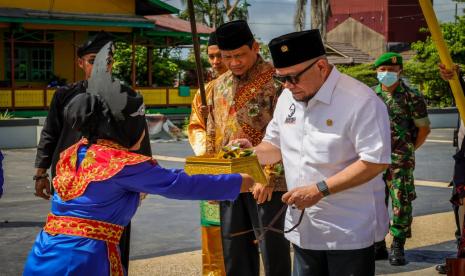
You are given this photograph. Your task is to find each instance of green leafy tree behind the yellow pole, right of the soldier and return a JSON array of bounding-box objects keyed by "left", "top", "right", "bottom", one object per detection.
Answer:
[{"left": 404, "top": 16, "right": 465, "bottom": 106}]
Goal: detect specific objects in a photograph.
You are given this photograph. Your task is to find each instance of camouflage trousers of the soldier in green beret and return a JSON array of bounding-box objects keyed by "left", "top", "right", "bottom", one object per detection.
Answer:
[{"left": 384, "top": 161, "right": 416, "bottom": 239}]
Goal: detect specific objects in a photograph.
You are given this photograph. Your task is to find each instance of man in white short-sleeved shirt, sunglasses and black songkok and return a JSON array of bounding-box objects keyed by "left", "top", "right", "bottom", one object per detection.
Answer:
[{"left": 238, "top": 30, "right": 391, "bottom": 276}]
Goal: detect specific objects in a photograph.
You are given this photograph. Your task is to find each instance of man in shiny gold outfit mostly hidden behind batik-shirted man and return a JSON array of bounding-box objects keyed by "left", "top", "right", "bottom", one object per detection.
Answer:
[{"left": 187, "top": 32, "right": 228, "bottom": 276}]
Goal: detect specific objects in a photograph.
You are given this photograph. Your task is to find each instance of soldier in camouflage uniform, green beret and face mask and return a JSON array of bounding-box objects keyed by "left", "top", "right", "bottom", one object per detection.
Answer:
[{"left": 374, "top": 52, "right": 430, "bottom": 265}]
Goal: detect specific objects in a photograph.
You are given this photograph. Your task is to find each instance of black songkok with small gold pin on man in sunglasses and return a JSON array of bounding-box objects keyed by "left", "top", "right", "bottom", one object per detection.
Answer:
[{"left": 268, "top": 29, "right": 326, "bottom": 68}]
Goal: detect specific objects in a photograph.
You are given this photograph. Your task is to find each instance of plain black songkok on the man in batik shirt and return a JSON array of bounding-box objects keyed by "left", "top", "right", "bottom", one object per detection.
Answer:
[{"left": 216, "top": 20, "right": 254, "bottom": 51}]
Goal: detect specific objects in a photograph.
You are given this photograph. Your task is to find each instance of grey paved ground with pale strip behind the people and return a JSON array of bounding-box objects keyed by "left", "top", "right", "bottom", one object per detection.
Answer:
[{"left": 0, "top": 129, "right": 455, "bottom": 275}]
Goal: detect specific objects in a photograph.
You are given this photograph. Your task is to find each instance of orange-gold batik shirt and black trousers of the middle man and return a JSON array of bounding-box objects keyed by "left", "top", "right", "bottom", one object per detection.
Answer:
[{"left": 204, "top": 56, "right": 290, "bottom": 275}]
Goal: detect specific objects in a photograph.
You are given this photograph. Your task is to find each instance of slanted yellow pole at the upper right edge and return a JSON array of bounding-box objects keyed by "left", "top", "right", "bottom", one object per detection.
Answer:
[{"left": 419, "top": 0, "right": 465, "bottom": 122}]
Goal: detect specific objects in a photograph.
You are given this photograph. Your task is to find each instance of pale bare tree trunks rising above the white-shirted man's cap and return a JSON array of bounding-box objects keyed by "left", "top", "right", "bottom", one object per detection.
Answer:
[{"left": 294, "top": 0, "right": 331, "bottom": 41}]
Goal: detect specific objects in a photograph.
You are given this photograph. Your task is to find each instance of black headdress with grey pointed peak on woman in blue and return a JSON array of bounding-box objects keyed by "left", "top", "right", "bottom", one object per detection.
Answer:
[{"left": 64, "top": 42, "right": 146, "bottom": 147}]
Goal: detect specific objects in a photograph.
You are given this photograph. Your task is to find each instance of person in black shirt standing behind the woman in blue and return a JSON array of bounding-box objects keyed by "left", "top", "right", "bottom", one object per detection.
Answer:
[{"left": 33, "top": 31, "right": 152, "bottom": 270}]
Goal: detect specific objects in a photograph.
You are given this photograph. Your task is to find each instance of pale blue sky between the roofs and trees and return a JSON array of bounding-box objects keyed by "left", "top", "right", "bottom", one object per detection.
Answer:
[{"left": 165, "top": 0, "right": 465, "bottom": 42}]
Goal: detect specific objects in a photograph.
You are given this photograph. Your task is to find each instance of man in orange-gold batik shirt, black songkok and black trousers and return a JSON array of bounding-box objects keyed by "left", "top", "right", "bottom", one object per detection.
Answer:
[{"left": 207, "top": 20, "right": 291, "bottom": 276}]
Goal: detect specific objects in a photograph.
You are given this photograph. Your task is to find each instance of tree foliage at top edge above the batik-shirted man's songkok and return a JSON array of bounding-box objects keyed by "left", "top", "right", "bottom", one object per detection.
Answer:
[{"left": 179, "top": 0, "right": 250, "bottom": 28}]
